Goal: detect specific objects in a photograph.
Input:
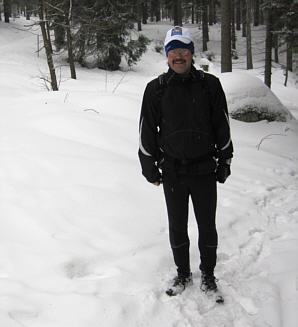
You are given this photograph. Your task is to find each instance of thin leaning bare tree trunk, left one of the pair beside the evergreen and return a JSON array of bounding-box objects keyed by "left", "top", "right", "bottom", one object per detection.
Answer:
[{"left": 38, "top": 0, "right": 58, "bottom": 91}]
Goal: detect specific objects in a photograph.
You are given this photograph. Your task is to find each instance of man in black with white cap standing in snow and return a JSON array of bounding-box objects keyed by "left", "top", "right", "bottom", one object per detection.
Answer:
[{"left": 139, "top": 26, "right": 233, "bottom": 296}]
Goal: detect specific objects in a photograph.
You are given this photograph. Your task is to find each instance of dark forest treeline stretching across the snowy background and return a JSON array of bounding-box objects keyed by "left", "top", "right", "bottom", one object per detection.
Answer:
[{"left": 0, "top": 0, "right": 298, "bottom": 87}]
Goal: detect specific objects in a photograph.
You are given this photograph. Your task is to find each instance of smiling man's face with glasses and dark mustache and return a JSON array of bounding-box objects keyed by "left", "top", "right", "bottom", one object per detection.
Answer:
[{"left": 168, "top": 48, "right": 193, "bottom": 74}]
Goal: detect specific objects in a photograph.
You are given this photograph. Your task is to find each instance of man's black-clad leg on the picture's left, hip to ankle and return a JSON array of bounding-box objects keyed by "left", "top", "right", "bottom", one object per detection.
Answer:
[{"left": 163, "top": 178, "right": 190, "bottom": 277}]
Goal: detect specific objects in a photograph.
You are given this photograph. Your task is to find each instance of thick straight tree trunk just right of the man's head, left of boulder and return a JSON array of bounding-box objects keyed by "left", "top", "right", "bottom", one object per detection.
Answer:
[{"left": 221, "top": 0, "right": 232, "bottom": 73}]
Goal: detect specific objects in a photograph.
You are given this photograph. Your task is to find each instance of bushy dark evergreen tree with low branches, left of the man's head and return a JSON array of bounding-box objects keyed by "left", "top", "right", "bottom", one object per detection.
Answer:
[{"left": 73, "top": 0, "right": 148, "bottom": 70}]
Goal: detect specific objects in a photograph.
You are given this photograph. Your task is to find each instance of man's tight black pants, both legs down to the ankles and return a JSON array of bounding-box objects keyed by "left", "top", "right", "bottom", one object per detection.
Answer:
[{"left": 163, "top": 174, "right": 217, "bottom": 275}]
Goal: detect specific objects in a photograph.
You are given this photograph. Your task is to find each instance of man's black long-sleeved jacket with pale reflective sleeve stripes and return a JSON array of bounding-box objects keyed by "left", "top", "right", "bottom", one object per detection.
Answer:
[{"left": 139, "top": 67, "right": 233, "bottom": 182}]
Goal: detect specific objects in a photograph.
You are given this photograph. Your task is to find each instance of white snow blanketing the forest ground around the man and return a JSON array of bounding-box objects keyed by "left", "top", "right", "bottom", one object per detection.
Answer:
[{"left": 0, "top": 18, "right": 298, "bottom": 327}]
